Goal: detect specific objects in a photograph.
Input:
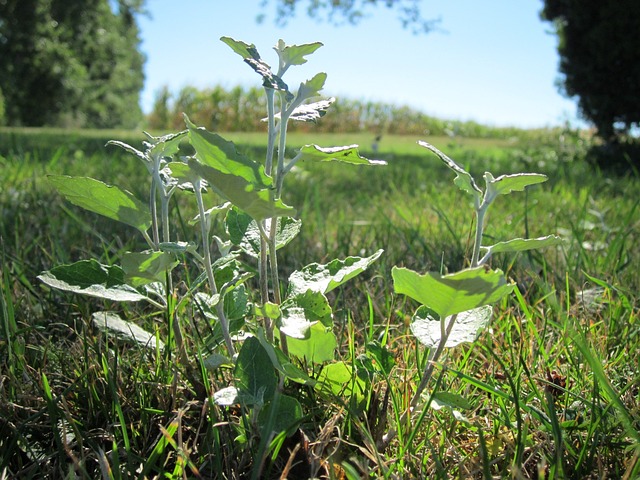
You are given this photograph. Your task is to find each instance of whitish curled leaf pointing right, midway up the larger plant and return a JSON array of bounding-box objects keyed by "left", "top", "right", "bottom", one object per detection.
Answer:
[{"left": 287, "top": 250, "right": 384, "bottom": 297}]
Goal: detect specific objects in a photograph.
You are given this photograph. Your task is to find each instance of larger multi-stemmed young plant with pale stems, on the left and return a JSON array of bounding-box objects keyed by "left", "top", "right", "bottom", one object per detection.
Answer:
[{"left": 39, "top": 37, "right": 385, "bottom": 477}]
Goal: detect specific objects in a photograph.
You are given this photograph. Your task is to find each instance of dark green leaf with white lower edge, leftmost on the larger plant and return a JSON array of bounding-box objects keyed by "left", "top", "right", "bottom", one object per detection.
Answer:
[{"left": 38, "top": 259, "right": 148, "bottom": 302}]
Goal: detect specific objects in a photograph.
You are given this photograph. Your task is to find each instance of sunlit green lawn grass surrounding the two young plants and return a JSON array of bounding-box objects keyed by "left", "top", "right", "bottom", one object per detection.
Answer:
[{"left": 0, "top": 125, "right": 640, "bottom": 479}]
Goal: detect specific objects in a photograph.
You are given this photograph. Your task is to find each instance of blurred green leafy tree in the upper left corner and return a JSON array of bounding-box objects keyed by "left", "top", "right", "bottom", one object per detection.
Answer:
[{"left": 0, "top": 0, "right": 144, "bottom": 128}]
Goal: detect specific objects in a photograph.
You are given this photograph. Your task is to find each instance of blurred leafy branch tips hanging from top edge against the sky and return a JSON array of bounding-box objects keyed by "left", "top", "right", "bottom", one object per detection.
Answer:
[{"left": 258, "top": 0, "right": 438, "bottom": 33}]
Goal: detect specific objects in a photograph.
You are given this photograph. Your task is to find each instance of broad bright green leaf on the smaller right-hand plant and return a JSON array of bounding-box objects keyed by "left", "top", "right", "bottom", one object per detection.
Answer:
[{"left": 391, "top": 267, "right": 514, "bottom": 318}]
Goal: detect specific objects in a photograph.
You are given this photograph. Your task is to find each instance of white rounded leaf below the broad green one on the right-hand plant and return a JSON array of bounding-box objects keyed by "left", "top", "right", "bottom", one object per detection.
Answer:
[{"left": 411, "top": 305, "right": 493, "bottom": 348}]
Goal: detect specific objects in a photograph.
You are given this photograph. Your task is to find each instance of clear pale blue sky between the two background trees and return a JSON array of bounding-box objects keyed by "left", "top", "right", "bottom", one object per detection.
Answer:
[{"left": 140, "top": 0, "right": 577, "bottom": 128}]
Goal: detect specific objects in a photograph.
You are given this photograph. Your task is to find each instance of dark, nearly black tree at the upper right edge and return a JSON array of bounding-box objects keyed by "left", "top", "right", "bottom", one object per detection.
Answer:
[{"left": 541, "top": 0, "right": 640, "bottom": 143}]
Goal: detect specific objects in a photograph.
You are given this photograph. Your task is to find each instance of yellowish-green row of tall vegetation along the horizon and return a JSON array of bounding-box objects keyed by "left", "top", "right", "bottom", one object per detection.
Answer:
[{"left": 147, "top": 86, "right": 522, "bottom": 138}]
